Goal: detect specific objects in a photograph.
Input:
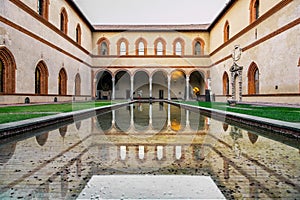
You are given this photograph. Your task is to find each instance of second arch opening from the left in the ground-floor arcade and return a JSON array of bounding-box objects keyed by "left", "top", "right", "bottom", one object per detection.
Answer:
[{"left": 115, "top": 71, "right": 130, "bottom": 99}]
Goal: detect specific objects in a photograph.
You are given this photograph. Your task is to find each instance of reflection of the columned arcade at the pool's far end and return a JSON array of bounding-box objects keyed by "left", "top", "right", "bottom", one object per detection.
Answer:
[{"left": 93, "top": 103, "right": 209, "bottom": 134}]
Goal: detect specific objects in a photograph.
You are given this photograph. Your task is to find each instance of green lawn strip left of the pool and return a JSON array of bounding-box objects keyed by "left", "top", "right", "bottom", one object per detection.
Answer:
[{"left": 0, "top": 101, "right": 111, "bottom": 124}]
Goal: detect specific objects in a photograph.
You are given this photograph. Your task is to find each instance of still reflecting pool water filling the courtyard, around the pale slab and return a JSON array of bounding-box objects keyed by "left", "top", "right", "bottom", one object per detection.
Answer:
[{"left": 0, "top": 103, "right": 300, "bottom": 199}]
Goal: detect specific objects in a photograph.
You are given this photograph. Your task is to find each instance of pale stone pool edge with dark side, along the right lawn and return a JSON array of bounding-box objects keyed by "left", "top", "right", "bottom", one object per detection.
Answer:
[{"left": 166, "top": 101, "right": 300, "bottom": 139}]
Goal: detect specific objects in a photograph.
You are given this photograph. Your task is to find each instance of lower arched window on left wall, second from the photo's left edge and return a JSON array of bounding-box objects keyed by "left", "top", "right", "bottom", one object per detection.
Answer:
[{"left": 35, "top": 61, "right": 49, "bottom": 94}]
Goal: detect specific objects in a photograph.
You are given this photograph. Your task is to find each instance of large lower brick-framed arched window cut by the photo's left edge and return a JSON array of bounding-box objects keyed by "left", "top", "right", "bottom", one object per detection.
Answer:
[{"left": 0, "top": 46, "right": 17, "bottom": 93}]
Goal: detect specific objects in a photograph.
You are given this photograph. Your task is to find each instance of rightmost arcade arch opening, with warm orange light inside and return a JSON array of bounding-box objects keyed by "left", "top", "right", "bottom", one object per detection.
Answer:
[{"left": 189, "top": 71, "right": 205, "bottom": 101}]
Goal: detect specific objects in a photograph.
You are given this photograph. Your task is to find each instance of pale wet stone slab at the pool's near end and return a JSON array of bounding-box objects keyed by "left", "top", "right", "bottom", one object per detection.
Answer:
[{"left": 77, "top": 175, "right": 226, "bottom": 200}]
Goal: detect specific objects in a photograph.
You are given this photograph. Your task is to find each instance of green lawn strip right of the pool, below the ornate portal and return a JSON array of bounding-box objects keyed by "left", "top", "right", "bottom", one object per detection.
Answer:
[{"left": 181, "top": 101, "right": 300, "bottom": 122}]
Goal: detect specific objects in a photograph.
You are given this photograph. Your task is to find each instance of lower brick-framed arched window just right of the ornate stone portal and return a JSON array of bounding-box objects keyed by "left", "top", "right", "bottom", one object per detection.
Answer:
[{"left": 248, "top": 62, "right": 259, "bottom": 94}]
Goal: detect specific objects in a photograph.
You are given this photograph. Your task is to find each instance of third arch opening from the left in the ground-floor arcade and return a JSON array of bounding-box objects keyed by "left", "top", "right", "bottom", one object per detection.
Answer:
[{"left": 133, "top": 71, "right": 150, "bottom": 99}]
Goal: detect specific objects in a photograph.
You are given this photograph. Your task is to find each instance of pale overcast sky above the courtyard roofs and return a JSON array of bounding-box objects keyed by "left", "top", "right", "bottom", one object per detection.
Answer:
[{"left": 74, "top": 0, "right": 228, "bottom": 24}]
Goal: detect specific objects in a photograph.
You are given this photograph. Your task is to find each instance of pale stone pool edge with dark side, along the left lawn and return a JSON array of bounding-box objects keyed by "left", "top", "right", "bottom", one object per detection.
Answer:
[{"left": 0, "top": 102, "right": 133, "bottom": 139}]
